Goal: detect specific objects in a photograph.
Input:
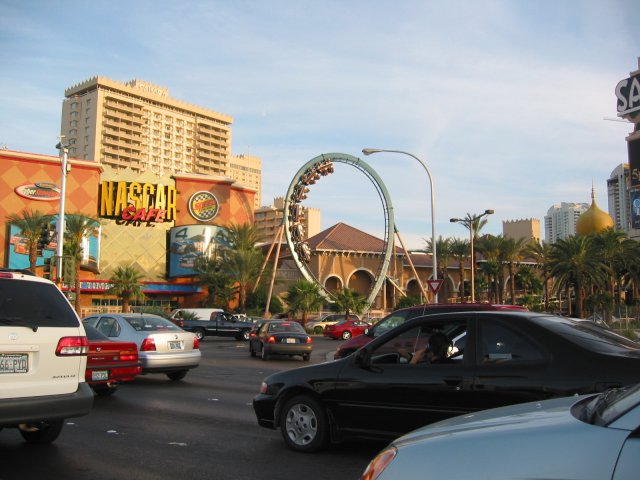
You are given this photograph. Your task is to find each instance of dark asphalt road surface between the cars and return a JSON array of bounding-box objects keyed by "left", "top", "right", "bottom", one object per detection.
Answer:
[{"left": 0, "top": 337, "right": 384, "bottom": 480}]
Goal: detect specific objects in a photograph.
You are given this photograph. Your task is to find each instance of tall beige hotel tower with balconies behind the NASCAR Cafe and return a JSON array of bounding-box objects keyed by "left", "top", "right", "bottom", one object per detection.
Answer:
[{"left": 61, "top": 77, "right": 261, "bottom": 202}]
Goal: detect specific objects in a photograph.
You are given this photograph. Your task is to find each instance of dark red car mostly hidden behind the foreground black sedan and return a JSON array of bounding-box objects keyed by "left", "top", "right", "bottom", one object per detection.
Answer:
[{"left": 333, "top": 303, "right": 527, "bottom": 360}]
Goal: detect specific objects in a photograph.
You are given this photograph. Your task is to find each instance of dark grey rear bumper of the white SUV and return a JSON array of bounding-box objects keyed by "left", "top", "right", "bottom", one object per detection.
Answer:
[{"left": 0, "top": 382, "right": 93, "bottom": 427}]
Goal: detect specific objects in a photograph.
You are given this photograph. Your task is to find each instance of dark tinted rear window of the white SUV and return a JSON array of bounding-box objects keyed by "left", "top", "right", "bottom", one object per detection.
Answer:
[{"left": 0, "top": 278, "right": 80, "bottom": 327}]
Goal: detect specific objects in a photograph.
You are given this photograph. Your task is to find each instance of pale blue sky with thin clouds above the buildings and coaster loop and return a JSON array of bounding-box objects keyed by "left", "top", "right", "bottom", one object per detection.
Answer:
[{"left": 0, "top": 0, "right": 640, "bottom": 248}]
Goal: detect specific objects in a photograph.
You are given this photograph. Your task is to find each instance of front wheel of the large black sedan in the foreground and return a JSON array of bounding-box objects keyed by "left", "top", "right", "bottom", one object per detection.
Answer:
[{"left": 280, "top": 395, "right": 329, "bottom": 452}]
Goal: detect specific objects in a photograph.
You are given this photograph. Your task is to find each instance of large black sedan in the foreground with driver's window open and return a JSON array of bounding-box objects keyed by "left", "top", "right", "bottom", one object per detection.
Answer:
[{"left": 253, "top": 311, "right": 640, "bottom": 452}]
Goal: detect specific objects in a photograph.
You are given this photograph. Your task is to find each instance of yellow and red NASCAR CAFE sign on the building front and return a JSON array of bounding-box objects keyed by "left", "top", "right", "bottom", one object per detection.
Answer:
[{"left": 100, "top": 181, "right": 178, "bottom": 223}]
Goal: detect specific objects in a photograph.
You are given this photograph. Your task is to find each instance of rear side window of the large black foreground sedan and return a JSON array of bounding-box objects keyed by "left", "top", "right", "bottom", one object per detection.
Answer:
[{"left": 478, "top": 321, "right": 544, "bottom": 364}]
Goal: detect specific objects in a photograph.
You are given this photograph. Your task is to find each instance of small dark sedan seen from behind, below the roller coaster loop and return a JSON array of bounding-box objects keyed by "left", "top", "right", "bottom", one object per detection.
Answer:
[{"left": 249, "top": 320, "right": 313, "bottom": 362}]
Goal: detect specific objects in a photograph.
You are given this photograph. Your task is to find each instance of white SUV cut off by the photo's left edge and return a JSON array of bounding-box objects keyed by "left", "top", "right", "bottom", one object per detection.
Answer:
[{"left": 0, "top": 269, "right": 93, "bottom": 443}]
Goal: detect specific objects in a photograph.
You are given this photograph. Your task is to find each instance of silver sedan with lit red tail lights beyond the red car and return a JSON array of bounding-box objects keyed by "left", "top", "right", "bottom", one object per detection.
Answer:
[{"left": 83, "top": 313, "right": 201, "bottom": 380}]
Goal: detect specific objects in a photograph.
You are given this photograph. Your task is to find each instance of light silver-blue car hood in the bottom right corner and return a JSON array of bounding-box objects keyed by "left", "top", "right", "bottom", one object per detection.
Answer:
[{"left": 362, "top": 385, "right": 640, "bottom": 480}]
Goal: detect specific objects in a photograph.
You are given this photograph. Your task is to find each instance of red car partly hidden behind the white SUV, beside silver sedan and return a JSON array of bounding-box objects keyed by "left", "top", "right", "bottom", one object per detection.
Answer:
[{"left": 84, "top": 323, "right": 142, "bottom": 396}]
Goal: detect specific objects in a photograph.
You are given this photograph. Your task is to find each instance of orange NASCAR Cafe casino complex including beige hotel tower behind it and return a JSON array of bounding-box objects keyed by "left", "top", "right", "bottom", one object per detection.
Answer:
[{"left": 0, "top": 77, "right": 261, "bottom": 315}]
